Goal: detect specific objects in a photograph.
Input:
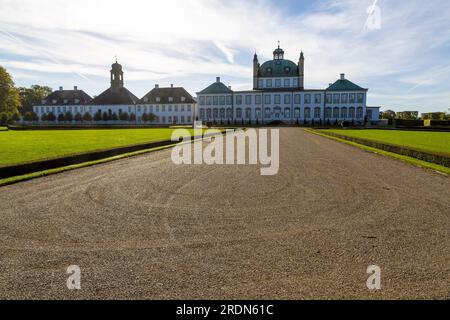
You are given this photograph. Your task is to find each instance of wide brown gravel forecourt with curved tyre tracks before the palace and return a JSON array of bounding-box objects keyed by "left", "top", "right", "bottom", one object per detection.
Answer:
[{"left": 0, "top": 128, "right": 450, "bottom": 299}]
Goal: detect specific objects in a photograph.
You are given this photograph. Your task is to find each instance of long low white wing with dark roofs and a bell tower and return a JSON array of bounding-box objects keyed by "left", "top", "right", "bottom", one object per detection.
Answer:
[{"left": 33, "top": 61, "right": 196, "bottom": 125}]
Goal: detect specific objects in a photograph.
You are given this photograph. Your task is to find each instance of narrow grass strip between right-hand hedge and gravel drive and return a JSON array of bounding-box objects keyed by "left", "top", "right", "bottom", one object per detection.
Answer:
[{"left": 304, "top": 129, "right": 450, "bottom": 175}]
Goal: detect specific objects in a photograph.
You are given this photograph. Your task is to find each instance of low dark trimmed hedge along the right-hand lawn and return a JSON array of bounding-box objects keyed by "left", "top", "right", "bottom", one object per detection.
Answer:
[{"left": 321, "top": 131, "right": 450, "bottom": 168}]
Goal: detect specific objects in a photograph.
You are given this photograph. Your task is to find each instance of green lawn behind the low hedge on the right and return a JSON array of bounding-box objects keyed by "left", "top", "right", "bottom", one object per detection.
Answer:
[{"left": 321, "top": 129, "right": 450, "bottom": 155}]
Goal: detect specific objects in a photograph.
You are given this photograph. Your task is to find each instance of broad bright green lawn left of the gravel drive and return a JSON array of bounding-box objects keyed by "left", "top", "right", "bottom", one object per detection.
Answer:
[{"left": 0, "top": 129, "right": 200, "bottom": 166}]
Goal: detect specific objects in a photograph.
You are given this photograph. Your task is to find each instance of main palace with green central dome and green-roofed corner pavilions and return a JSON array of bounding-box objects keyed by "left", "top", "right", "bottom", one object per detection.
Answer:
[{"left": 197, "top": 46, "right": 379, "bottom": 125}]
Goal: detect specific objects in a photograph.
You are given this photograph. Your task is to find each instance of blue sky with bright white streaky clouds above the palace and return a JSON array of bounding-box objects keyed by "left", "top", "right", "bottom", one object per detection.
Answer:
[{"left": 0, "top": 0, "right": 450, "bottom": 112}]
